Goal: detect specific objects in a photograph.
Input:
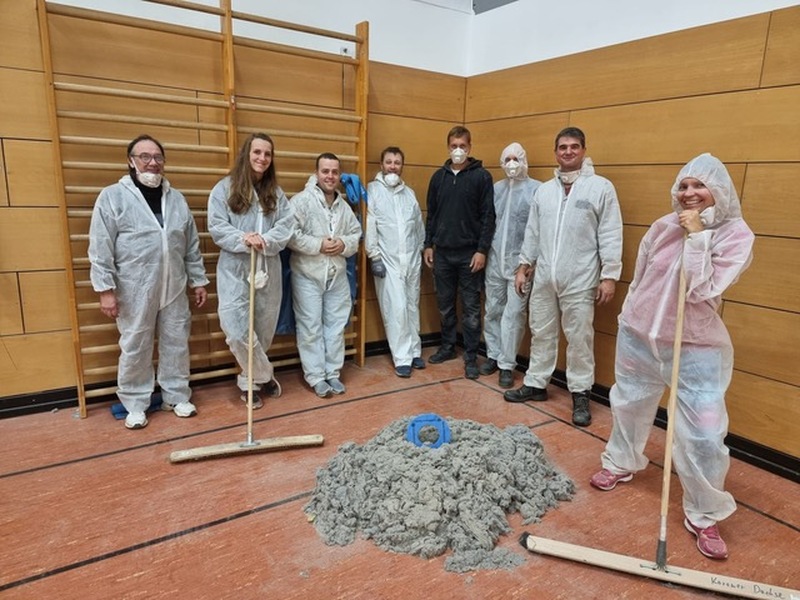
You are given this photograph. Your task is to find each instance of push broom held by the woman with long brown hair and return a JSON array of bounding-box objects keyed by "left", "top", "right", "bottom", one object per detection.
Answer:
[{"left": 169, "top": 247, "right": 325, "bottom": 463}]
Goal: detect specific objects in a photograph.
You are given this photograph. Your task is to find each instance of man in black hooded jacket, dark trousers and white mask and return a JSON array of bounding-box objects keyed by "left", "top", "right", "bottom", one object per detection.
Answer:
[{"left": 424, "top": 126, "right": 495, "bottom": 379}]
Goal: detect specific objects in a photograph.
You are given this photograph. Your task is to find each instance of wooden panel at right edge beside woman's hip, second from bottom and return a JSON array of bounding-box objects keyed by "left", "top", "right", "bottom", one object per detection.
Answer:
[{"left": 723, "top": 302, "right": 800, "bottom": 386}]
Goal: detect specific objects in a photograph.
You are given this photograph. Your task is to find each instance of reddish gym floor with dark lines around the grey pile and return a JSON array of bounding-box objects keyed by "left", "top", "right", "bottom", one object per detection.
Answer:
[{"left": 0, "top": 349, "right": 800, "bottom": 600}]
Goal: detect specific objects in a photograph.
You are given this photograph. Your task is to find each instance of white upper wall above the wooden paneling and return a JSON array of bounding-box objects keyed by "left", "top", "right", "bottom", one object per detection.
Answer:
[{"left": 50, "top": 0, "right": 799, "bottom": 76}]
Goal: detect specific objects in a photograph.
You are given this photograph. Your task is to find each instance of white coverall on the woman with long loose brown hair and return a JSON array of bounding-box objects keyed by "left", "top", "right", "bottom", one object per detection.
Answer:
[{"left": 208, "top": 177, "right": 294, "bottom": 391}]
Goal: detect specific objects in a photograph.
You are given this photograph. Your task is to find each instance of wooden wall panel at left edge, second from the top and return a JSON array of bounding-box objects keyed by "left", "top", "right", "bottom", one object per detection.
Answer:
[{"left": 0, "top": 68, "right": 50, "bottom": 140}]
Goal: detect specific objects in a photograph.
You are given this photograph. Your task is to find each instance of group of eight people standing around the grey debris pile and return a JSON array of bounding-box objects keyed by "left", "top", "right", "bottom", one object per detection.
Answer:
[{"left": 89, "top": 126, "right": 754, "bottom": 559}]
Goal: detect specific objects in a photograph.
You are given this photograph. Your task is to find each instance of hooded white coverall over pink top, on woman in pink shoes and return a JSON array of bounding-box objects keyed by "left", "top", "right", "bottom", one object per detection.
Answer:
[{"left": 602, "top": 154, "right": 754, "bottom": 527}]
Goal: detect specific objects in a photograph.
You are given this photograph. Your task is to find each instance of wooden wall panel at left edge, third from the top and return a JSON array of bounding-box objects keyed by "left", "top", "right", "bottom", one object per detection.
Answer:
[{"left": 4, "top": 140, "right": 59, "bottom": 207}]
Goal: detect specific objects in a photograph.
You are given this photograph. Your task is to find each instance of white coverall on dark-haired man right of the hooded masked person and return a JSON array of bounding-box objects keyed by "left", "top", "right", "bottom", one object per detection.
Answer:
[{"left": 520, "top": 157, "right": 622, "bottom": 392}]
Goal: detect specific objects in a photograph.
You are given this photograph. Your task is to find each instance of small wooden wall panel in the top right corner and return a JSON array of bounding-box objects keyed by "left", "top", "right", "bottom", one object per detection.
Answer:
[{"left": 761, "top": 6, "right": 800, "bottom": 87}]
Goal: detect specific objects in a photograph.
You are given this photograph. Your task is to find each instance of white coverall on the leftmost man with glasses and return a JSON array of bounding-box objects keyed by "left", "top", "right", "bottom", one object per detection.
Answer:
[{"left": 89, "top": 175, "right": 208, "bottom": 413}]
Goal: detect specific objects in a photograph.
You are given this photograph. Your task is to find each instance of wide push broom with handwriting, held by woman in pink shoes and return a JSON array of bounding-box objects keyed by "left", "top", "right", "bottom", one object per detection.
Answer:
[{"left": 519, "top": 255, "right": 800, "bottom": 600}]
